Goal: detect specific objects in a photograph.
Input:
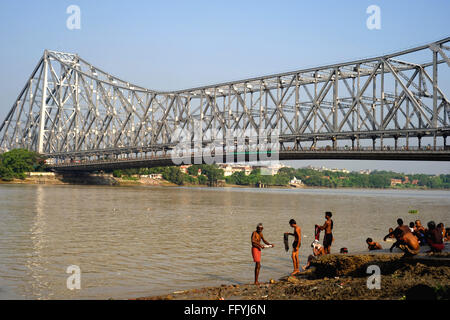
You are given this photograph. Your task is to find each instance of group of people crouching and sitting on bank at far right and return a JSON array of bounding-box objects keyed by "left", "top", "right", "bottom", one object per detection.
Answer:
[{"left": 366, "top": 218, "right": 450, "bottom": 255}]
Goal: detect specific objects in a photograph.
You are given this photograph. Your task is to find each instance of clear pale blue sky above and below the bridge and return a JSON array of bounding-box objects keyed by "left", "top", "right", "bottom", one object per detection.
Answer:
[{"left": 0, "top": 0, "right": 450, "bottom": 174}]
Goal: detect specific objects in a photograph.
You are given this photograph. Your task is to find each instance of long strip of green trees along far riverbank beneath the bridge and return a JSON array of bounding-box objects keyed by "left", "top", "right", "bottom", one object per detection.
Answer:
[{"left": 103, "top": 164, "right": 450, "bottom": 189}]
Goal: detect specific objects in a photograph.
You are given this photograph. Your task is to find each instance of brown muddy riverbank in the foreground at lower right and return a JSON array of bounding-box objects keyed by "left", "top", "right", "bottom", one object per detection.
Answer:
[{"left": 137, "top": 252, "right": 450, "bottom": 300}]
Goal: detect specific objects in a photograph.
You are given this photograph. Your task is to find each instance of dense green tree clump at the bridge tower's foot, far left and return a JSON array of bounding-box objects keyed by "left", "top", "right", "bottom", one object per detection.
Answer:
[{"left": 0, "top": 149, "right": 47, "bottom": 181}]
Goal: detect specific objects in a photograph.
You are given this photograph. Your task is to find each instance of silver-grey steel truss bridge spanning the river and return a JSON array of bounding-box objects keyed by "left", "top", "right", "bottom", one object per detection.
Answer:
[{"left": 0, "top": 37, "right": 450, "bottom": 171}]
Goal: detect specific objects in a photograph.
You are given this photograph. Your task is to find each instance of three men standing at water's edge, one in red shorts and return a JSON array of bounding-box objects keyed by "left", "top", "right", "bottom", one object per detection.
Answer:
[{"left": 251, "top": 211, "right": 334, "bottom": 284}]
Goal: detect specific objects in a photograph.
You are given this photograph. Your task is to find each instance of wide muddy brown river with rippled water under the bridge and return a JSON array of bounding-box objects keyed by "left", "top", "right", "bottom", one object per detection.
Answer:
[{"left": 0, "top": 184, "right": 450, "bottom": 299}]
